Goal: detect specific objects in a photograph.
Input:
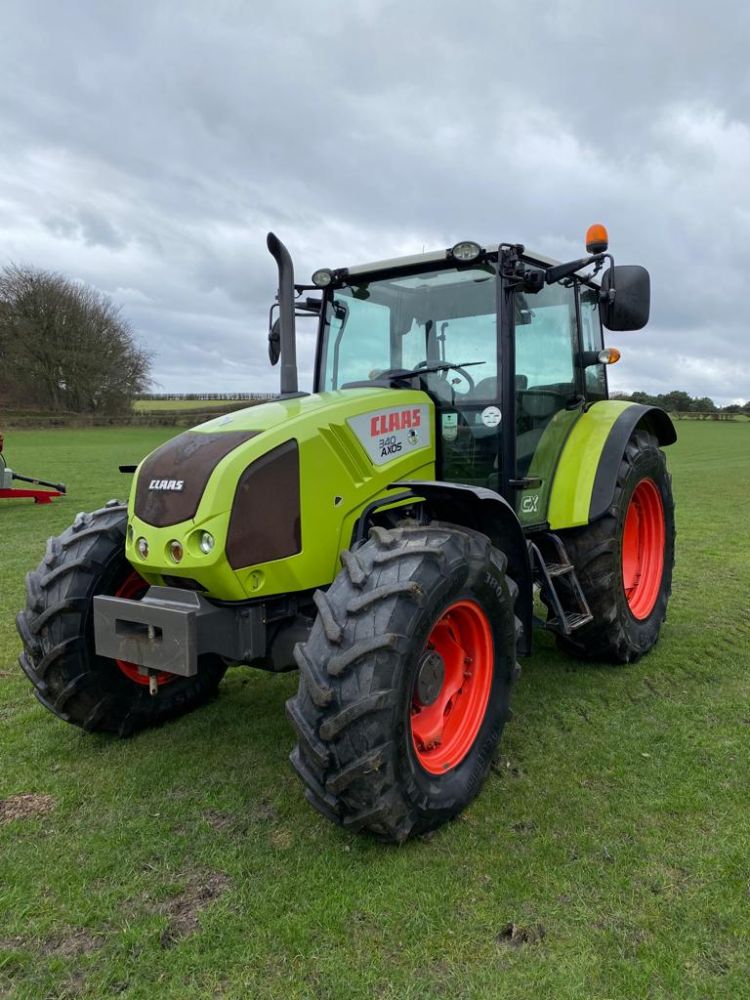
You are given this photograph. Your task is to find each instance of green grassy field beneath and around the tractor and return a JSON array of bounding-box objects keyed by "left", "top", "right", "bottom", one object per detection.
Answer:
[{"left": 0, "top": 422, "right": 750, "bottom": 1000}]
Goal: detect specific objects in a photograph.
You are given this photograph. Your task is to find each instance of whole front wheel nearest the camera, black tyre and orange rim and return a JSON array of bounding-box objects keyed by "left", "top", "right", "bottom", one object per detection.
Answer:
[{"left": 287, "top": 524, "right": 521, "bottom": 841}]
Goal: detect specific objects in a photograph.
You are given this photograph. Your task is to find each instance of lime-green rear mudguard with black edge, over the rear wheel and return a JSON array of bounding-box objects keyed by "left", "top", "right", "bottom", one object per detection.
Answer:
[{"left": 548, "top": 399, "right": 677, "bottom": 530}]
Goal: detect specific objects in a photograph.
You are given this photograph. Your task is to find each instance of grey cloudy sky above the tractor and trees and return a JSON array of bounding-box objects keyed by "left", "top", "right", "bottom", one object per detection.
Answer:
[{"left": 0, "top": 0, "right": 750, "bottom": 402}]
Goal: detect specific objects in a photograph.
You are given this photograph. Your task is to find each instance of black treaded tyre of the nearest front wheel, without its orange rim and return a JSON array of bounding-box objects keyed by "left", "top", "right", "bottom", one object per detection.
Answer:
[{"left": 287, "top": 523, "right": 520, "bottom": 842}]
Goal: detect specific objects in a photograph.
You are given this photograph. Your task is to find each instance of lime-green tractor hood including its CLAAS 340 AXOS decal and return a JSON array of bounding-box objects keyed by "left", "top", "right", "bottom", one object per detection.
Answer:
[{"left": 127, "top": 388, "right": 435, "bottom": 600}]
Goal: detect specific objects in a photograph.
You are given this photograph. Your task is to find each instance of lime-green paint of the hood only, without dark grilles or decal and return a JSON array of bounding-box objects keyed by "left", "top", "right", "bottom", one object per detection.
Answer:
[{"left": 126, "top": 388, "right": 435, "bottom": 600}]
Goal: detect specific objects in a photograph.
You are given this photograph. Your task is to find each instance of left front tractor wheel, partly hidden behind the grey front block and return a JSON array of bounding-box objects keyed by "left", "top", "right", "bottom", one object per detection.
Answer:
[{"left": 16, "top": 501, "right": 226, "bottom": 736}]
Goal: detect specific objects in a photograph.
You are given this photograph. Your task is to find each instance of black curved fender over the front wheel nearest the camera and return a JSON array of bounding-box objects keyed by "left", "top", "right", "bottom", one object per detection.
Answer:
[{"left": 393, "top": 481, "right": 533, "bottom": 655}]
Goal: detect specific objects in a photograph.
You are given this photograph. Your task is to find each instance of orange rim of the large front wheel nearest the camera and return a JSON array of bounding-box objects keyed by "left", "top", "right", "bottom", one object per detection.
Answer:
[{"left": 411, "top": 601, "right": 495, "bottom": 774}]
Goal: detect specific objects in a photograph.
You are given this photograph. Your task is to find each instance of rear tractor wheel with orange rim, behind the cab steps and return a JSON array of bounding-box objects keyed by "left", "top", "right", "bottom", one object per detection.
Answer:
[{"left": 557, "top": 430, "right": 675, "bottom": 663}]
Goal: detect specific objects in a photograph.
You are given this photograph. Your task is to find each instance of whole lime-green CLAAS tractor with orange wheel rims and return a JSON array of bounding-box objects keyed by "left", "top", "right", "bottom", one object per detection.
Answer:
[{"left": 18, "top": 226, "right": 676, "bottom": 841}]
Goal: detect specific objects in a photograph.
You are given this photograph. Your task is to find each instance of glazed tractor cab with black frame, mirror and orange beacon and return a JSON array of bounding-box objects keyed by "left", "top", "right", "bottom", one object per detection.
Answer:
[{"left": 300, "top": 227, "right": 648, "bottom": 528}]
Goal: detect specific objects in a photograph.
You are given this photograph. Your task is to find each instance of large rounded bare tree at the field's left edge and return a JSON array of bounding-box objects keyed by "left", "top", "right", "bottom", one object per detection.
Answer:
[{"left": 0, "top": 265, "right": 151, "bottom": 413}]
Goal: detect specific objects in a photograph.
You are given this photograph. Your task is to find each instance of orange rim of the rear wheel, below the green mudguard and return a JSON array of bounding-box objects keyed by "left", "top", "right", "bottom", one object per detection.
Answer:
[{"left": 622, "top": 479, "right": 666, "bottom": 621}]
